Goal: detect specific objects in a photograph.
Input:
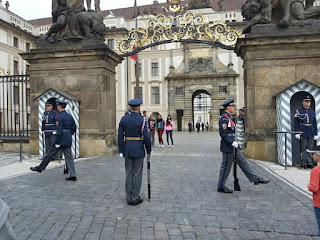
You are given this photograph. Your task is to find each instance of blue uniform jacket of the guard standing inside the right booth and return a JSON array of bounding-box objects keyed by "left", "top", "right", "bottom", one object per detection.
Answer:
[{"left": 294, "top": 107, "right": 318, "bottom": 138}]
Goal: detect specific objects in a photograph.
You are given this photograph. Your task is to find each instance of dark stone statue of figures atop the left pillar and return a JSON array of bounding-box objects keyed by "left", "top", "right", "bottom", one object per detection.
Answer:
[{"left": 45, "top": 0, "right": 106, "bottom": 43}]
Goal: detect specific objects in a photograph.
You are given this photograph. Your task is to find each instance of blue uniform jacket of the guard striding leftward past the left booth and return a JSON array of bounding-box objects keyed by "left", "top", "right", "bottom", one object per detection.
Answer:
[{"left": 54, "top": 110, "right": 77, "bottom": 146}]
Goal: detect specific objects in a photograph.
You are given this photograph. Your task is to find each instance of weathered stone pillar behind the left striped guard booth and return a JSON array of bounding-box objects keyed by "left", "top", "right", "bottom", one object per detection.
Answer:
[{"left": 21, "top": 44, "right": 122, "bottom": 157}]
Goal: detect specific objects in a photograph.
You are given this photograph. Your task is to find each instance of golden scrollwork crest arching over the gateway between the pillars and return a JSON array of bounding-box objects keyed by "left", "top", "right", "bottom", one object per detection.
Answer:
[{"left": 117, "top": 0, "right": 241, "bottom": 56}]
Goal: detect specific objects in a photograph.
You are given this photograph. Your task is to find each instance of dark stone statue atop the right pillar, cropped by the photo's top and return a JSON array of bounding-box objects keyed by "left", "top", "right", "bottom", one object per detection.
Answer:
[{"left": 241, "top": 0, "right": 320, "bottom": 33}]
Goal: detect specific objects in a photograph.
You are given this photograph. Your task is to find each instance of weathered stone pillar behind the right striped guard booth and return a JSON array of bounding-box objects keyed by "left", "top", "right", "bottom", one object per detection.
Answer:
[{"left": 235, "top": 24, "right": 320, "bottom": 161}]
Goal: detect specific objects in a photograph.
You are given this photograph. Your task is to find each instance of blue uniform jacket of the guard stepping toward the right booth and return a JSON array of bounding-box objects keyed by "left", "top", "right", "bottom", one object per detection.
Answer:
[{"left": 219, "top": 112, "right": 236, "bottom": 153}]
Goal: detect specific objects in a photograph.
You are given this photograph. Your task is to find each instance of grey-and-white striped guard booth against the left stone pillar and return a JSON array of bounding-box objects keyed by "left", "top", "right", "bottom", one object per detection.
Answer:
[{"left": 35, "top": 88, "right": 80, "bottom": 159}]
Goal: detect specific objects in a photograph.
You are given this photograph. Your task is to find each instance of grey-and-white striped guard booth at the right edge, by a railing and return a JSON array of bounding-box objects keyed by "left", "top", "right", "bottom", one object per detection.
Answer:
[{"left": 276, "top": 80, "right": 320, "bottom": 166}]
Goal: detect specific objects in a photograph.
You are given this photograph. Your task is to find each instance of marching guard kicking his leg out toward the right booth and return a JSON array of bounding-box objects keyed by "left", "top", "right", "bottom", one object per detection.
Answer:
[{"left": 218, "top": 99, "right": 270, "bottom": 193}]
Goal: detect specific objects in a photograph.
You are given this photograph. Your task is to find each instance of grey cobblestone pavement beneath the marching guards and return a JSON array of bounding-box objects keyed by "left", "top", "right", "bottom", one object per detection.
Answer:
[{"left": 0, "top": 132, "right": 319, "bottom": 240}]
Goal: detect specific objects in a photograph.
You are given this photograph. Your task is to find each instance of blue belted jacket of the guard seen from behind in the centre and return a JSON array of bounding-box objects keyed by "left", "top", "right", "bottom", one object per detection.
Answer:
[{"left": 118, "top": 112, "right": 151, "bottom": 158}]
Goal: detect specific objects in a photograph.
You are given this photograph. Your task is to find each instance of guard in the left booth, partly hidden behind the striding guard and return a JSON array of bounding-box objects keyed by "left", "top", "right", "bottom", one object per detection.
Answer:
[{"left": 41, "top": 101, "right": 57, "bottom": 154}]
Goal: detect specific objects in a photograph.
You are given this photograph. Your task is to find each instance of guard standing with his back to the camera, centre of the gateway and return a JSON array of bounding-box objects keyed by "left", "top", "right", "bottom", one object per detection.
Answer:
[{"left": 118, "top": 98, "right": 151, "bottom": 206}]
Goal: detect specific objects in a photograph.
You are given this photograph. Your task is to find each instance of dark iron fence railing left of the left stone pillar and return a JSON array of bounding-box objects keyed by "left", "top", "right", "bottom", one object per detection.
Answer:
[{"left": 0, "top": 75, "right": 30, "bottom": 139}]
